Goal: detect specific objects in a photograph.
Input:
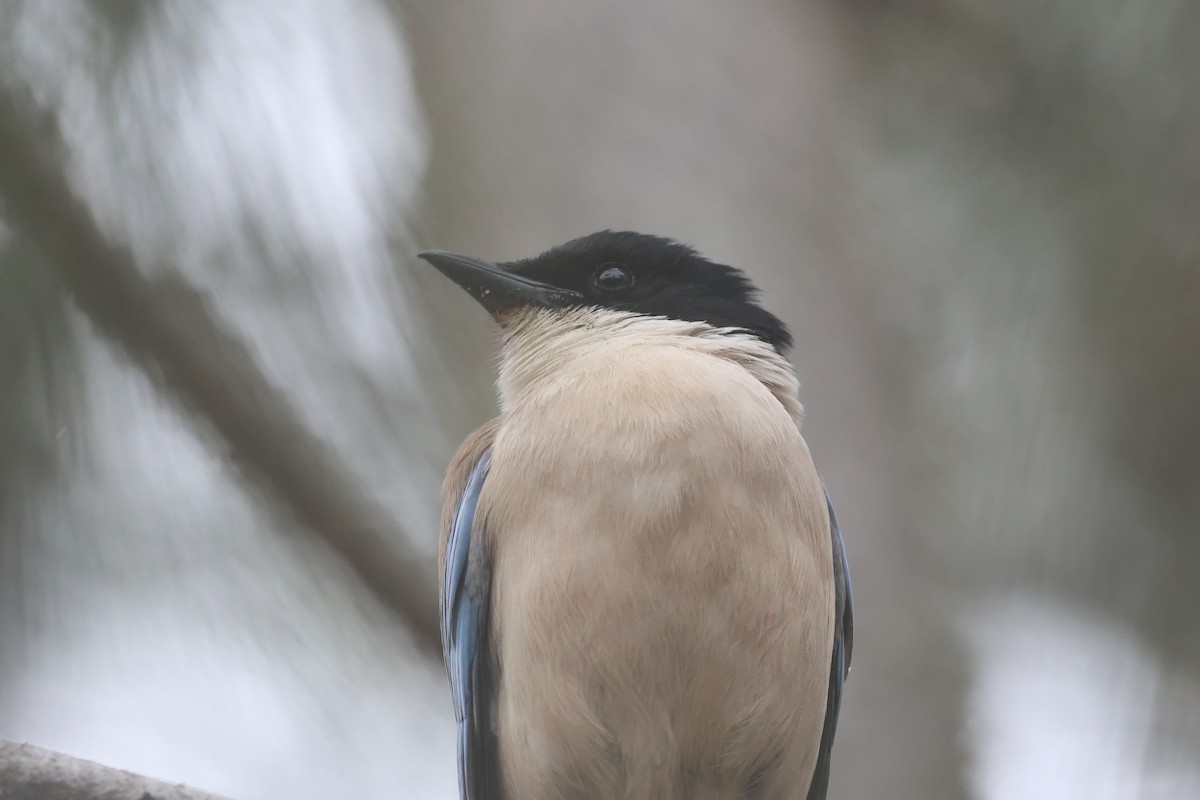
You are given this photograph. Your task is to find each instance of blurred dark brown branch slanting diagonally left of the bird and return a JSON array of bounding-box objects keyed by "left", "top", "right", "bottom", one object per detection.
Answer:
[{"left": 0, "top": 82, "right": 438, "bottom": 651}]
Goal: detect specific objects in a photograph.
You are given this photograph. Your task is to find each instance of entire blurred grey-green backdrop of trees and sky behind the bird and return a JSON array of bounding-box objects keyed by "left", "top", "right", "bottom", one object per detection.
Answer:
[{"left": 0, "top": 0, "right": 1200, "bottom": 800}]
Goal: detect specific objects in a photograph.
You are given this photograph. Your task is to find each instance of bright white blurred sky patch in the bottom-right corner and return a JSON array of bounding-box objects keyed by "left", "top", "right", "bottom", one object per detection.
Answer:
[{"left": 962, "top": 595, "right": 1200, "bottom": 800}]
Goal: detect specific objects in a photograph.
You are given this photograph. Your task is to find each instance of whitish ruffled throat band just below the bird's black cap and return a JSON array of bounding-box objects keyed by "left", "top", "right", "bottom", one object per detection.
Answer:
[{"left": 498, "top": 308, "right": 804, "bottom": 427}]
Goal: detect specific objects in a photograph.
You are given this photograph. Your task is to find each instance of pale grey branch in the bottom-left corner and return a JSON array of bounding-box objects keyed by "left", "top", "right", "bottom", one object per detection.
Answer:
[{"left": 0, "top": 739, "right": 229, "bottom": 800}]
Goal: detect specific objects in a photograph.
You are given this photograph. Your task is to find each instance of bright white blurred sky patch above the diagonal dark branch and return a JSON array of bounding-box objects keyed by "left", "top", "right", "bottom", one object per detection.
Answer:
[{"left": 13, "top": 0, "right": 440, "bottom": 544}]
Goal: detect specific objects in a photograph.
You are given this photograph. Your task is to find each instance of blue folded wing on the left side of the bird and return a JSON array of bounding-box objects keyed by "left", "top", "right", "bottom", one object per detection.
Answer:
[{"left": 440, "top": 449, "right": 493, "bottom": 800}]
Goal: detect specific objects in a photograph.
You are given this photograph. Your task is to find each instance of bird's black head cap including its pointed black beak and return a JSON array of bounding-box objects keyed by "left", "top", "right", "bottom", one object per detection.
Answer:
[{"left": 421, "top": 230, "right": 792, "bottom": 353}]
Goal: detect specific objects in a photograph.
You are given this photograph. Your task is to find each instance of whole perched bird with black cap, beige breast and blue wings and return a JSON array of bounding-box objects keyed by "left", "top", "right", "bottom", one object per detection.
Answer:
[{"left": 419, "top": 230, "right": 853, "bottom": 800}]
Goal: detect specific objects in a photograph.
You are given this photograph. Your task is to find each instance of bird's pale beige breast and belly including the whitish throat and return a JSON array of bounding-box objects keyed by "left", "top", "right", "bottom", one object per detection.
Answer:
[{"left": 446, "top": 312, "right": 834, "bottom": 800}]
